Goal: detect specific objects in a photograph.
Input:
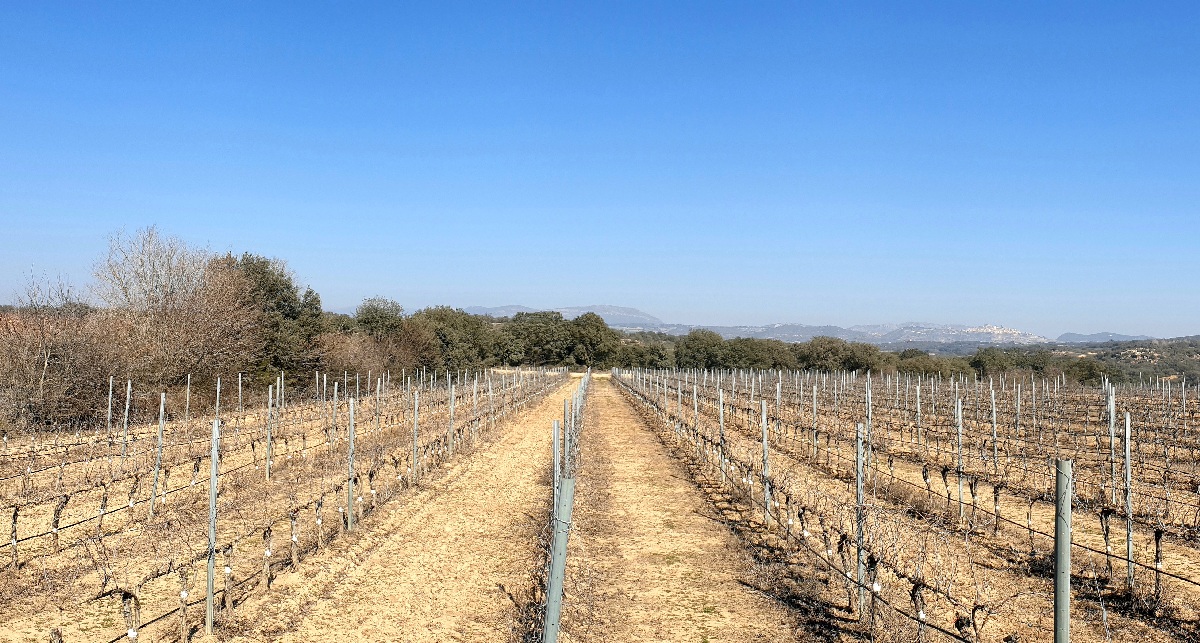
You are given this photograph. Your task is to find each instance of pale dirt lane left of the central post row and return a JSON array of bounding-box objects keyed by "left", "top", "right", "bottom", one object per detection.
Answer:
[{"left": 230, "top": 380, "right": 577, "bottom": 642}]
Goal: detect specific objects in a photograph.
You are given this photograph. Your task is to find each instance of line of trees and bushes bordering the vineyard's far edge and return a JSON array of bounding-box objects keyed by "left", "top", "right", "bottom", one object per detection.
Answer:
[{"left": 0, "top": 228, "right": 1152, "bottom": 426}]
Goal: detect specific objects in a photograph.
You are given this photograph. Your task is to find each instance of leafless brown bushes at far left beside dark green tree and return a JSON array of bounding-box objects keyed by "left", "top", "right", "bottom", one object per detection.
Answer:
[{"left": 0, "top": 228, "right": 263, "bottom": 426}]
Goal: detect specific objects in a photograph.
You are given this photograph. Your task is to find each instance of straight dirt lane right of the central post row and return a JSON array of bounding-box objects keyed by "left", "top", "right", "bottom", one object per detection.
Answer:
[{"left": 564, "top": 378, "right": 796, "bottom": 643}]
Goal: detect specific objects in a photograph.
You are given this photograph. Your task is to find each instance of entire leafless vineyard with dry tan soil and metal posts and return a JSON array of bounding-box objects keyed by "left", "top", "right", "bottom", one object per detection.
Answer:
[{"left": 0, "top": 368, "right": 1200, "bottom": 643}]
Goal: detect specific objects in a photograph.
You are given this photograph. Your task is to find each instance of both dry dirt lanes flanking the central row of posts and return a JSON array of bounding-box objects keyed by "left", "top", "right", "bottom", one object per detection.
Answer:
[{"left": 222, "top": 378, "right": 796, "bottom": 643}]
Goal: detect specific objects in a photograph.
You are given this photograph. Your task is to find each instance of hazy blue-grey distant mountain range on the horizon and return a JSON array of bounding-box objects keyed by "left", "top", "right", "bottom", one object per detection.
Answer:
[{"left": 466, "top": 306, "right": 1152, "bottom": 349}]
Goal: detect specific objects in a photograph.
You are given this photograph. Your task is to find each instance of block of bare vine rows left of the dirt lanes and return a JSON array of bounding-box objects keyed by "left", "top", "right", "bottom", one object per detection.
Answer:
[{"left": 0, "top": 369, "right": 565, "bottom": 641}]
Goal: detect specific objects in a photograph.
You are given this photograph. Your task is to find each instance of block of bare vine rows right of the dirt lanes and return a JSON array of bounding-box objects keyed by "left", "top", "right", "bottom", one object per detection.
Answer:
[{"left": 619, "top": 371, "right": 1200, "bottom": 641}]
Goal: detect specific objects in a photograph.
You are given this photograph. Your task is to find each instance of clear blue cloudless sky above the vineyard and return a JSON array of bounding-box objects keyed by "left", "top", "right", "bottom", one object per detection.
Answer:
[{"left": 0, "top": 1, "right": 1200, "bottom": 336}]
